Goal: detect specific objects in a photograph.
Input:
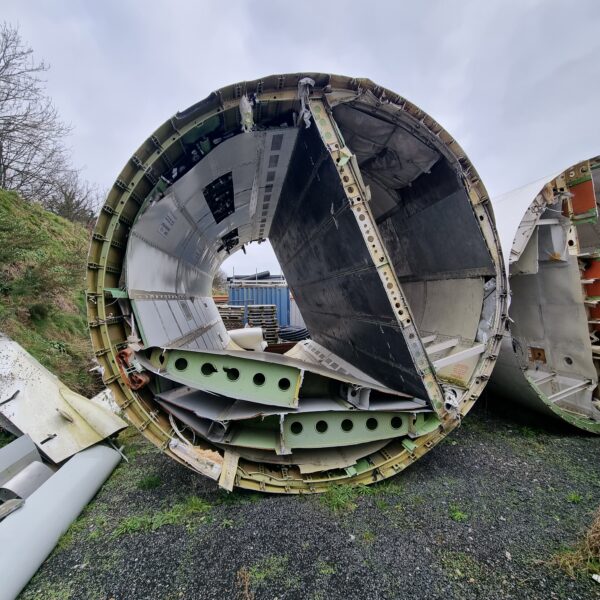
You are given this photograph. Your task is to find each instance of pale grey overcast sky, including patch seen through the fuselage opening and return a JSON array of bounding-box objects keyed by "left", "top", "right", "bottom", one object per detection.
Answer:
[{"left": 0, "top": 0, "right": 600, "bottom": 273}]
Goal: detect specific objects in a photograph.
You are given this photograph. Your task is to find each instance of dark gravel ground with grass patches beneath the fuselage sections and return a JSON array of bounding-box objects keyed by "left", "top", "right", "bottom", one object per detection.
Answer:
[{"left": 20, "top": 400, "right": 600, "bottom": 600}]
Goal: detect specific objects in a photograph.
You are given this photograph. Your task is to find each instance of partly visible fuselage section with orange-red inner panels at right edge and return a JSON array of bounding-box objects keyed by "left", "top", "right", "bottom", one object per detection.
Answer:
[{"left": 490, "top": 156, "right": 600, "bottom": 434}]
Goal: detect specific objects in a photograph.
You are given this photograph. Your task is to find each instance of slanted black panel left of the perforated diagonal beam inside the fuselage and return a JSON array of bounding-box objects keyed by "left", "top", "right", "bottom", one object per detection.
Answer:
[{"left": 269, "top": 124, "right": 427, "bottom": 399}]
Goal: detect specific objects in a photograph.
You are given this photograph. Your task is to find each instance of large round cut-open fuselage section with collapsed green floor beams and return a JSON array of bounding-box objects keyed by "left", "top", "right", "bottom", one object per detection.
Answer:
[{"left": 87, "top": 73, "right": 507, "bottom": 493}]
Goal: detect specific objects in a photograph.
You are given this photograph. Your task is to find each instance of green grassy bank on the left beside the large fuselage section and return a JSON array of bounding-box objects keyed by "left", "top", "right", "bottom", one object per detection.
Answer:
[{"left": 0, "top": 190, "right": 101, "bottom": 396}]
